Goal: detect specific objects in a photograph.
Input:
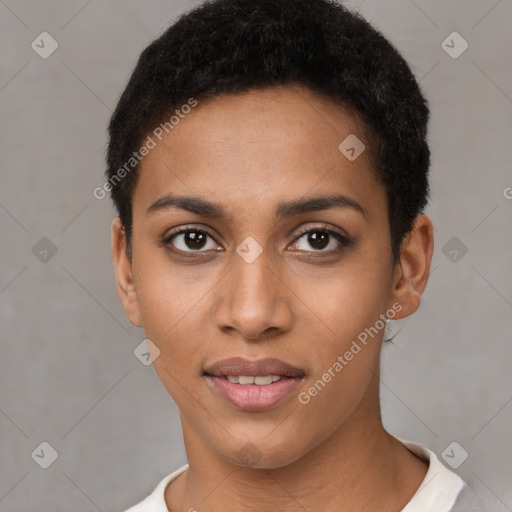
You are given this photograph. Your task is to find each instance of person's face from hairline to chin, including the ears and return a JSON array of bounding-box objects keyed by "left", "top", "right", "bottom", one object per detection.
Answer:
[{"left": 113, "top": 87, "right": 430, "bottom": 468}]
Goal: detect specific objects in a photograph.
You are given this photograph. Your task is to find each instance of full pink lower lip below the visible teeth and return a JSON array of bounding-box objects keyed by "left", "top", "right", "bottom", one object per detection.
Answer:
[{"left": 206, "top": 375, "right": 302, "bottom": 411}]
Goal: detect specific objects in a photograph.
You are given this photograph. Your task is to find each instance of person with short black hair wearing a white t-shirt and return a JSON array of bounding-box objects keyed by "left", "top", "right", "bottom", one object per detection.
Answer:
[{"left": 102, "top": 0, "right": 480, "bottom": 512}]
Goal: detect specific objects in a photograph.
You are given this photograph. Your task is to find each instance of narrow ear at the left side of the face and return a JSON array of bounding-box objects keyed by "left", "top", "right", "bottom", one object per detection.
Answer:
[{"left": 112, "top": 217, "right": 142, "bottom": 327}]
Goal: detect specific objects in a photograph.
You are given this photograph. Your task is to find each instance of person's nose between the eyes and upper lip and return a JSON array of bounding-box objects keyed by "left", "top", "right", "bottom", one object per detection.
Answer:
[{"left": 215, "top": 251, "right": 293, "bottom": 341}]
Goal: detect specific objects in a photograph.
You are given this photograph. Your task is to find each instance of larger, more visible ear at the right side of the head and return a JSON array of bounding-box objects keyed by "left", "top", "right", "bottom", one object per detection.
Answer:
[{"left": 392, "top": 215, "right": 434, "bottom": 319}]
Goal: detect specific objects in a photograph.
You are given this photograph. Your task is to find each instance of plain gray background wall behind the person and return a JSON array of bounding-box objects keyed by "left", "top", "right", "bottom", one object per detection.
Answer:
[{"left": 0, "top": 0, "right": 512, "bottom": 512}]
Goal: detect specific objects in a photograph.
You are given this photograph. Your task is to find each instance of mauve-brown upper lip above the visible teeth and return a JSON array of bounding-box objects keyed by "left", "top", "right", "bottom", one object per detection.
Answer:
[{"left": 205, "top": 357, "right": 304, "bottom": 377}]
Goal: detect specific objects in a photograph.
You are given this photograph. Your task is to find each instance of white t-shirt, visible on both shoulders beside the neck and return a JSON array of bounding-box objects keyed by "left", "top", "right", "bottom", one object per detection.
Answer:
[{"left": 125, "top": 439, "right": 484, "bottom": 512}]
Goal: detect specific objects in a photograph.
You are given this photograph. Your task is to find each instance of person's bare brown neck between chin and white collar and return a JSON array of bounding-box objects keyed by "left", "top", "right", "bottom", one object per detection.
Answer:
[{"left": 165, "top": 376, "right": 428, "bottom": 512}]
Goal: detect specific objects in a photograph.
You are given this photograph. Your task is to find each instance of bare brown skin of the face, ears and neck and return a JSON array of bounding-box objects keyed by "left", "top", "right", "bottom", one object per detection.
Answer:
[{"left": 112, "top": 86, "right": 433, "bottom": 512}]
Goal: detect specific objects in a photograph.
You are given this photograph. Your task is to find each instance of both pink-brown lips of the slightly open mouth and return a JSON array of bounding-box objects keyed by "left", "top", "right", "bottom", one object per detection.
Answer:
[{"left": 205, "top": 357, "right": 304, "bottom": 412}]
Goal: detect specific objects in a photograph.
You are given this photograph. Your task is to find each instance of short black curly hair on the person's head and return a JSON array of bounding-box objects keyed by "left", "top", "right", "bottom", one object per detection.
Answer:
[{"left": 106, "top": 0, "right": 430, "bottom": 262}]
